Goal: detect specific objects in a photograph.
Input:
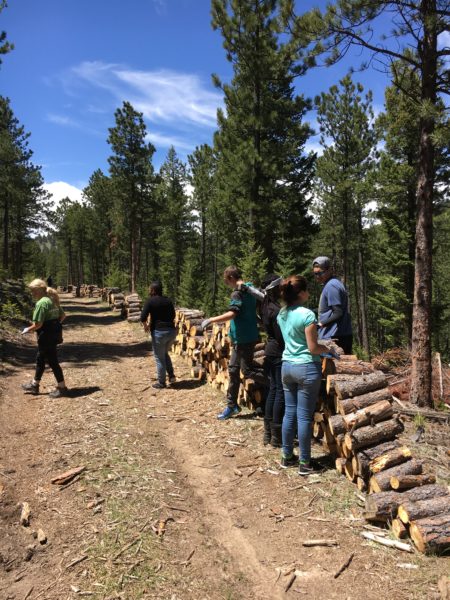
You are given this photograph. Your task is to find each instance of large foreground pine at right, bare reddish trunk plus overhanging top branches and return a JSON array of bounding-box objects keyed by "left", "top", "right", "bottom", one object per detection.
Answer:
[{"left": 283, "top": 0, "right": 450, "bottom": 406}]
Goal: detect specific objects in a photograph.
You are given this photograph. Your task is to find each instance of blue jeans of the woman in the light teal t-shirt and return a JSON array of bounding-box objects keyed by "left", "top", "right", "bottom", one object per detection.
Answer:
[{"left": 281, "top": 361, "right": 322, "bottom": 462}]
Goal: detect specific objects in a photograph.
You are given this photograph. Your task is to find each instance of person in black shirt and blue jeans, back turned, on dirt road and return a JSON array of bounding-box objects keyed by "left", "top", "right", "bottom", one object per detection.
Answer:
[{"left": 141, "top": 281, "right": 177, "bottom": 389}]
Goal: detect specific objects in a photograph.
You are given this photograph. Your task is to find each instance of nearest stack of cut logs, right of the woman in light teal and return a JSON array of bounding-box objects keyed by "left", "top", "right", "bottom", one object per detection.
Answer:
[{"left": 320, "top": 356, "right": 450, "bottom": 552}]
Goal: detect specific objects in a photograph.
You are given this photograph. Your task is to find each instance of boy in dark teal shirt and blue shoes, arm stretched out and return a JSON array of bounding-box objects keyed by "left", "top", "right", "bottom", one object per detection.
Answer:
[{"left": 202, "top": 267, "right": 259, "bottom": 420}]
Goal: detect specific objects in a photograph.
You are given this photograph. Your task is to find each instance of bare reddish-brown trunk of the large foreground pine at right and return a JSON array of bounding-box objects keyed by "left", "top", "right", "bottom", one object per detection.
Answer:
[{"left": 410, "top": 0, "right": 437, "bottom": 406}]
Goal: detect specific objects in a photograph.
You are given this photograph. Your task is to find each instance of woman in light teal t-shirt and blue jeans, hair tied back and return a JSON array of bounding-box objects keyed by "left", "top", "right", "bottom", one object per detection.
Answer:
[{"left": 277, "top": 275, "right": 329, "bottom": 475}]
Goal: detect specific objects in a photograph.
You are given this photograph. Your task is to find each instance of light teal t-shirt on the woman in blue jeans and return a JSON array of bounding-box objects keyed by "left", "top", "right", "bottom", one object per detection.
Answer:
[{"left": 277, "top": 306, "right": 320, "bottom": 365}]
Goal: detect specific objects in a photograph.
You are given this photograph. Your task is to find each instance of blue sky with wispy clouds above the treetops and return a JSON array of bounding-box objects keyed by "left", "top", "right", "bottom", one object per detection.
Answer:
[{"left": 0, "top": 0, "right": 420, "bottom": 200}]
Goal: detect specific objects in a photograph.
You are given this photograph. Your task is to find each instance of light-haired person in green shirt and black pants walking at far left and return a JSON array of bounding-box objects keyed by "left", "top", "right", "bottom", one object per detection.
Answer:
[{"left": 22, "top": 279, "right": 68, "bottom": 398}]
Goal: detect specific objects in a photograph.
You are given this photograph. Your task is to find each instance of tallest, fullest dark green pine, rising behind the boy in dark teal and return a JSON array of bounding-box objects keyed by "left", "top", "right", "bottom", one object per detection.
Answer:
[{"left": 212, "top": 0, "right": 314, "bottom": 270}]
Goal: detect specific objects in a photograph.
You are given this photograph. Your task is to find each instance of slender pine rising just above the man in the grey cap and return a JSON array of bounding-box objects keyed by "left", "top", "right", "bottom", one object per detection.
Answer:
[{"left": 316, "top": 76, "right": 376, "bottom": 354}]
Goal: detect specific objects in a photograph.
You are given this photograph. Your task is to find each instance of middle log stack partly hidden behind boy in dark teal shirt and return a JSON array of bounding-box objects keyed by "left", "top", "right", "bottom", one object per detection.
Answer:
[{"left": 172, "top": 308, "right": 264, "bottom": 406}]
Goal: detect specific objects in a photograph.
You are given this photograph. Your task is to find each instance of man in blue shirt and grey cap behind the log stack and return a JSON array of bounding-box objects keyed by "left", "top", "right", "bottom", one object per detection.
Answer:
[{"left": 313, "top": 256, "right": 353, "bottom": 354}]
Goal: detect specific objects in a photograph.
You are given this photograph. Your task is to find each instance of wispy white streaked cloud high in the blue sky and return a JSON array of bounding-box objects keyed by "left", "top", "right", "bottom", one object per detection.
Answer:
[{"left": 72, "top": 61, "right": 222, "bottom": 128}]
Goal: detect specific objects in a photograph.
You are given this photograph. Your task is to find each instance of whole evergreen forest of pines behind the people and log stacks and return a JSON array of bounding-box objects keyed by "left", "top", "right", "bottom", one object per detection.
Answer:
[{"left": 0, "top": 0, "right": 450, "bottom": 404}]
